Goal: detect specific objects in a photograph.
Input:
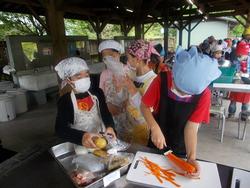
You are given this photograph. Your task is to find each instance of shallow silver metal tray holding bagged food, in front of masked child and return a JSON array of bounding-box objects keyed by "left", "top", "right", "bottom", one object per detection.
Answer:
[{"left": 50, "top": 142, "right": 133, "bottom": 188}]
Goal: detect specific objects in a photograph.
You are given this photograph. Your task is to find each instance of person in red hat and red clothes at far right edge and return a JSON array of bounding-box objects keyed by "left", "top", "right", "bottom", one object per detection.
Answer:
[{"left": 228, "top": 40, "right": 250, "bottom": 118}]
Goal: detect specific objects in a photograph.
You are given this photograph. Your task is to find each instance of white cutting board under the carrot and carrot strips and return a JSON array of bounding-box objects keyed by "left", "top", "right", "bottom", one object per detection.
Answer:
[{"left": 126, "top": 152, "right": 221, "bottom": 188}]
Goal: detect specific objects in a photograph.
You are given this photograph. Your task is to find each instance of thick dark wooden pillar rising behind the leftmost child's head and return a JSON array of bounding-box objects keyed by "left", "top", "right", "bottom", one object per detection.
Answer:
[{"left": 45, "top": 0, "right": 68, "bottom": 65}]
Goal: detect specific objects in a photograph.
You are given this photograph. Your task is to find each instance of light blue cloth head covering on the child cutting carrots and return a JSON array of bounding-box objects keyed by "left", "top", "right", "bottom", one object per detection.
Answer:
[{"left": 173, "top": 46, "right": 221, "bottom": 95}]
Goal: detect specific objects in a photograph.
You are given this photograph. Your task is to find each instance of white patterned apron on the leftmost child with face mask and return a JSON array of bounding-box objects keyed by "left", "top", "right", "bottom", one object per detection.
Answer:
[{"left": 71, "top": 91, "right": 105, "bottom": 133}]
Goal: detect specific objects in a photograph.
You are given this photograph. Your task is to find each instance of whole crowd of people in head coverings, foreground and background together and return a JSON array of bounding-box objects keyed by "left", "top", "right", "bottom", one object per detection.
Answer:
[{"left": 55, "top": 25, "right": 250, "bottom": 178}]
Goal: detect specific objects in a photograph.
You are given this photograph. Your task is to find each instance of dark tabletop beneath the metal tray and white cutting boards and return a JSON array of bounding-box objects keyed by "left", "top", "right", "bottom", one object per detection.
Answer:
[{"left": 0, "top": 142, "right": 238, "bottom": 188}]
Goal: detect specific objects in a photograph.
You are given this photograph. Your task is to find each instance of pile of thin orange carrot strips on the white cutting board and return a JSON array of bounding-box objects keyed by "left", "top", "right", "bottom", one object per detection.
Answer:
[{"left": 141, "top": 157, "right": 180, "bottom": 187}]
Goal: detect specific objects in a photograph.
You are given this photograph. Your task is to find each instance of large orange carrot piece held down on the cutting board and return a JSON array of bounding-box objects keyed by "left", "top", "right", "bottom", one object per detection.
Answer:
[{"left": 164, "top": 151, "right": 196, "bottom": 173}]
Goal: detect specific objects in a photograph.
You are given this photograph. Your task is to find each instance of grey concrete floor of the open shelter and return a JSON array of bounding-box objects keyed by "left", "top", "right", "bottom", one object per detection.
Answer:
[{"left": 0, "top": 101, "right": 250, "bottom": 170}]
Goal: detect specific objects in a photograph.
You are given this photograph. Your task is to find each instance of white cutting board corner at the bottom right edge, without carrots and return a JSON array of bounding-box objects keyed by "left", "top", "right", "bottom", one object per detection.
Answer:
[{"left": 231, "top": 168, "right": 250, "bottom": 188}]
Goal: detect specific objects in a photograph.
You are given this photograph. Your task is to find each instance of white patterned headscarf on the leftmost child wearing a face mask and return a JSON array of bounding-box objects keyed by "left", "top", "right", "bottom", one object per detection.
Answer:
[{"left": 55, "top": 57, "right": 89, "bottom": 80}]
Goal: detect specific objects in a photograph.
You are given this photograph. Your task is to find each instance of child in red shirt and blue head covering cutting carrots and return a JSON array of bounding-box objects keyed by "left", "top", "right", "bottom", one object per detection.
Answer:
[{"left": 141, "top": 46, "right": 221, "bottom": 177}]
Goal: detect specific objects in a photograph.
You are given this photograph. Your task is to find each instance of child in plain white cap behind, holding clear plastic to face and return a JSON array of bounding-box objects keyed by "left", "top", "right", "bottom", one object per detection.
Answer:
[{"left": 98, "top": 40, "right": 132, "bottom": 142}]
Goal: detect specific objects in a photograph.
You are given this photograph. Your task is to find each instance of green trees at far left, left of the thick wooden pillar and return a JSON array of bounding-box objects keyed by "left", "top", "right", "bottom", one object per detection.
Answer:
[{"left": 0, "top": 12, "right": 46, "bottom": 40}]
